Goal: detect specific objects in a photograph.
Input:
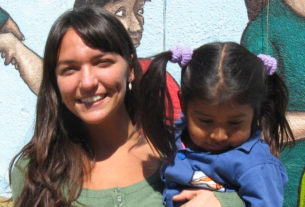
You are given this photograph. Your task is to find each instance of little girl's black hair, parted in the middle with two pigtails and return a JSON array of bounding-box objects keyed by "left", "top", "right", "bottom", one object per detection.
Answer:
[{"left": 139, "top": 42, "right": 294, "bottom": 157}]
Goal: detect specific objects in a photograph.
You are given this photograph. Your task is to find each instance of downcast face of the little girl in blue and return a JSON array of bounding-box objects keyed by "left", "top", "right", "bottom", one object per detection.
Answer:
[{"left": 182, "top": 100, "right": 254, "bottom": 152}]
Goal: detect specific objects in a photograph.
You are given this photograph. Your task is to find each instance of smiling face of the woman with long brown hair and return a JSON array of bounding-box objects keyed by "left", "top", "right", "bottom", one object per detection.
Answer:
[{"left": 56, "top": 29, "right": 133, "bottom": 124}]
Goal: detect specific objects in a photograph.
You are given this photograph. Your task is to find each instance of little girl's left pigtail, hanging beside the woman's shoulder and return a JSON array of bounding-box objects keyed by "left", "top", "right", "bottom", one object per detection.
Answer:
[{"left": 138, "top": 51, "right": 175, "bottom": 160}]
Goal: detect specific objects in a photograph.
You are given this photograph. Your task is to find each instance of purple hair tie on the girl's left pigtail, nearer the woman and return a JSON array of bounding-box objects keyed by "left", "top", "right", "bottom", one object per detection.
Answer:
[{"left": 169, "top": 45, "right": 193, "bottom": 67}]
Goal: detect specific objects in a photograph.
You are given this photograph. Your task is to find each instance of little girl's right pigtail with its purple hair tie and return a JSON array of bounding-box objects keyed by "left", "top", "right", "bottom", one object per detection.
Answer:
[{"left": 258, "top": 55, "right": 295, "bottom": 156}]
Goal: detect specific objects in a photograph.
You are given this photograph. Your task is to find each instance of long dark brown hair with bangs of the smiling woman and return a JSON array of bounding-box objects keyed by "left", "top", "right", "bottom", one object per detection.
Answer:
[{"left": 10, "top": 4, "right": 142, "bottom": 207}]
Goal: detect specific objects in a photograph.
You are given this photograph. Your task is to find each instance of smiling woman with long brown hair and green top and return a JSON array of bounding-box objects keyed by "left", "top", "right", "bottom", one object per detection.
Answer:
[{"left": 10, "top": 5, "right": 241, "bottom": 207}]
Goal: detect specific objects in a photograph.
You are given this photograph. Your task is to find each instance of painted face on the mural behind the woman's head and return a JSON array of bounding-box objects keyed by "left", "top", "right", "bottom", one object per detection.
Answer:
[{"left": 104, "top": 0, "right": 145, "bottom": 47}]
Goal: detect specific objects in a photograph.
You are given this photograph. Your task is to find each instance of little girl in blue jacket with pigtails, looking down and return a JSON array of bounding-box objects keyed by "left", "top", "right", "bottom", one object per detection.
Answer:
[{"left": 140, "top": 42, "right": 294, "bottom": 207}]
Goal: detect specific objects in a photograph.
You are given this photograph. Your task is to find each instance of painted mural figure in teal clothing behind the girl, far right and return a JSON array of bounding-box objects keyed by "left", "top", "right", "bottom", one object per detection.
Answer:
[{"left": 241, "top": 0, "right": 305, "bottom": 206}]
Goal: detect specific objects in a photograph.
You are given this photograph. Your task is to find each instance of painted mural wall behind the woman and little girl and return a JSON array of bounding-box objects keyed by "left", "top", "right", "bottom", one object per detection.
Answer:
[{"left": 0, "top": 0, "right": 305, "bottom": 206}]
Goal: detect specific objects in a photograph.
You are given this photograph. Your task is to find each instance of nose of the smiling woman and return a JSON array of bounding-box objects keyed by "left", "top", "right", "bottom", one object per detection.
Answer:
[{"left": 79, "top": 66, "right": 98, "bottom": 90}]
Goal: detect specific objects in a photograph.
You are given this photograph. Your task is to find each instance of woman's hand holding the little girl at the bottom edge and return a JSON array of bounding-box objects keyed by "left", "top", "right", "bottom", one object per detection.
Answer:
[{"left": 173, "top": 188, "right": 221, "bottom": 207}]
